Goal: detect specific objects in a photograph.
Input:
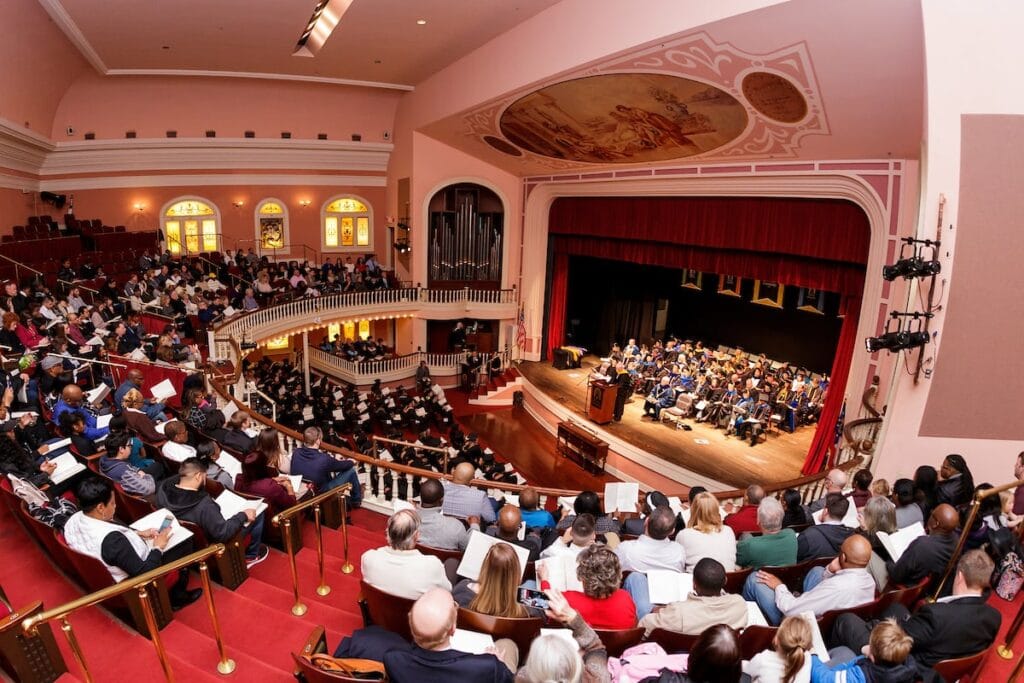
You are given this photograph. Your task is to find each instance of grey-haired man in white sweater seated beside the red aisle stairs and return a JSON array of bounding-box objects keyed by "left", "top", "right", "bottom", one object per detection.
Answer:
[{"left": 361, "top": 510, "right": 452, "bottom": 599}]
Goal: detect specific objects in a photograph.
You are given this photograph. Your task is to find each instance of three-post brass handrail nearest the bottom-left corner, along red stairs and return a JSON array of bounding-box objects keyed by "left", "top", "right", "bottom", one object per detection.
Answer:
[{"left": 22, "top": 543, "right": 234, "bottom": 683}]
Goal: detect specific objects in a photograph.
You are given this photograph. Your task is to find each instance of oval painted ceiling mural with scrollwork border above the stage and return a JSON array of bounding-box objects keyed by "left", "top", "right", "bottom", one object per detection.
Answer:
[{"left": 424, "top": 33, "right": 830, "bottom": 174}]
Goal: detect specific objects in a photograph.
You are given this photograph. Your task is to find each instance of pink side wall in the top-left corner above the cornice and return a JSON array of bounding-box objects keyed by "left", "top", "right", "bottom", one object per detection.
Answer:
[{"left": 0, "top": 0, "right": 91, "bottom": 135}]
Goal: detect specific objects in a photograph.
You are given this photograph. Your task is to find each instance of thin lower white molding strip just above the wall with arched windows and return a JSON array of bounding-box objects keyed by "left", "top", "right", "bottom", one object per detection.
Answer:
[{"left": 37, "top": 173, "right": 387, "bottom": 193}]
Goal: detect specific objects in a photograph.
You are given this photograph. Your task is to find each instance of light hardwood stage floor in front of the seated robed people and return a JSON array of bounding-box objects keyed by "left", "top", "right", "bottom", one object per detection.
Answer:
[{"left": 516, "top": 355, "right": 815, "bottom": 488}]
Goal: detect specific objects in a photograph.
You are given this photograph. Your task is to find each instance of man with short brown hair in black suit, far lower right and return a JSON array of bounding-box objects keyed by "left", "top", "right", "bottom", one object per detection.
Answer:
[{"left": 831, "top": 550, "right": 1002, "bottom": 667}]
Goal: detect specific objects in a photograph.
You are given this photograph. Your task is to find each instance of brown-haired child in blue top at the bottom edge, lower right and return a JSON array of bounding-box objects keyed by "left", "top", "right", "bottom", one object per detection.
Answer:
[{"left": 811, "top": 620, "right": 921, "bottom": 683}]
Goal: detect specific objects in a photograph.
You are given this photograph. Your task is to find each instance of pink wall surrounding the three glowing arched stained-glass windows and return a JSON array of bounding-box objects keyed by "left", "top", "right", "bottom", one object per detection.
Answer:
[{"left": 61, "top": 185, "right": 390, "bottom": 260}]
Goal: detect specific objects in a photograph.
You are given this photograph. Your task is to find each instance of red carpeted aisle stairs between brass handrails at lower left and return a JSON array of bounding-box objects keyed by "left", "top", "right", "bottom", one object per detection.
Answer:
[{"left": 0, "top": 499, "right": 385, "bottom": 683}]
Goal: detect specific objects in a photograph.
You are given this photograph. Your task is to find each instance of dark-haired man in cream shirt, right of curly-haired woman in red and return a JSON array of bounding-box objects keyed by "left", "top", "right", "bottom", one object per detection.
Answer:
[{"left": 626, "top": 557, "right": 748, "bottom": 636}]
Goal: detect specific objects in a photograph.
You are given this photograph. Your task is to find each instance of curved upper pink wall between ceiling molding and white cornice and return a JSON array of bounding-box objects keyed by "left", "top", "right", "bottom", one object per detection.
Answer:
[{"left": 47, "top": 72, "right": 401, "bottom": 142}]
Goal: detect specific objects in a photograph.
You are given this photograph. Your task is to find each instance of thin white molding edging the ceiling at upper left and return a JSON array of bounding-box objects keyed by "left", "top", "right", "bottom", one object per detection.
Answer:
[{"left": 39, "top": 0, "right": 416, "bottom": 91}]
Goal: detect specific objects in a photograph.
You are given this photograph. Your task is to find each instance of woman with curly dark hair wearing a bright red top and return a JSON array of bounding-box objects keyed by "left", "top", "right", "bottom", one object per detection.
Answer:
[{"left": 537, "top": 544, "right": 637, "bottom": 629}]
